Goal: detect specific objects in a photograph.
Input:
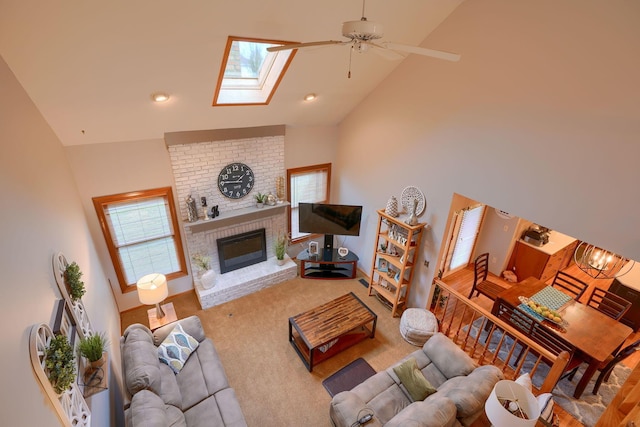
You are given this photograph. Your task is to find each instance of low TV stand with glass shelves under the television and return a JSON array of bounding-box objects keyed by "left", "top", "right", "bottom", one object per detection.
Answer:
[{"left": 298, "top": 249, "right": 359, "bottom": 280}]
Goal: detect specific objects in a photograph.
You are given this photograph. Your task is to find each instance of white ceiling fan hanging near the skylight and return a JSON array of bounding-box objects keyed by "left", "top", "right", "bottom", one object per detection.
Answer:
[{"left": 267, "top": 0, "right": 460, "bottom": 77}]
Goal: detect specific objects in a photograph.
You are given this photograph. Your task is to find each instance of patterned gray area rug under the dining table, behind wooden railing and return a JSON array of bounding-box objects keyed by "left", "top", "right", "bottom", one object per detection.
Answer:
[{"left": 463, "top": 318, "right": 631, "bottom": 427}]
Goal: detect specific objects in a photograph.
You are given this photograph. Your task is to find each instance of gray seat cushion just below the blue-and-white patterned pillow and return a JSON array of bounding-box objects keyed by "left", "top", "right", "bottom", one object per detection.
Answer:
[{"left": 176, "top": 338, "right": 229, "bottom": 410}]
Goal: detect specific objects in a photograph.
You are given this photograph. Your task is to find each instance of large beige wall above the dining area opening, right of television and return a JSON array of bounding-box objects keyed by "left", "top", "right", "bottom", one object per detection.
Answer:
[{"left": 338, "top": 0, "right": 640, "bottom": 306}]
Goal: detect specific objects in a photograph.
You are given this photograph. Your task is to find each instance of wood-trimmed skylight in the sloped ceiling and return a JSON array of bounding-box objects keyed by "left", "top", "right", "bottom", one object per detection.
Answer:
[{"left": 213, "top": 37, "right": 296, "bottom": 106}]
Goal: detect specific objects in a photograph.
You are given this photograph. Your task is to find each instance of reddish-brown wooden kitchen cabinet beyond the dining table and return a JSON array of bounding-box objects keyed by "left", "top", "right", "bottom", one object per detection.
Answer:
[{"left": 507, "top": 240, "right": 578, "bottom": 282}]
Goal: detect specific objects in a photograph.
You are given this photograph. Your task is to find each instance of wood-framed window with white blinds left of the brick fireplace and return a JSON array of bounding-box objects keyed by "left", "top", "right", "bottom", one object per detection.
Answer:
[{"left": 93, "top": 187, "right": 187, "bottom": 292}]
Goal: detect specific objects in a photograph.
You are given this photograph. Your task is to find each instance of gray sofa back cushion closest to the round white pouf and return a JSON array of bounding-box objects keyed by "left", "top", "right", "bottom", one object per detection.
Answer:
[{"left": 422, "top": 332, "right": 476, "bottom": 378}]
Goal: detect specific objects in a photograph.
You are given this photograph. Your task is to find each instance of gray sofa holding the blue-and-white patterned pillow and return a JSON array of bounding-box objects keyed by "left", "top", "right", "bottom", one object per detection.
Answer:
[{"left": 120, "top": 316, "right": 247, "bottom": 427}]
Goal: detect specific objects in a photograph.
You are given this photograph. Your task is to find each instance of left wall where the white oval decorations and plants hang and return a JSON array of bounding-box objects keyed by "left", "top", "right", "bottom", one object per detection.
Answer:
[{"left": 0, "top": 58, "right": 122, "bottom": 426}]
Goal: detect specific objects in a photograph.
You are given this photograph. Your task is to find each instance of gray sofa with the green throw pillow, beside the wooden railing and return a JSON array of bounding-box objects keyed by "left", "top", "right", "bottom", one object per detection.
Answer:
[{"left": 329, "top": 333, "right": 504, "bottom": 427}]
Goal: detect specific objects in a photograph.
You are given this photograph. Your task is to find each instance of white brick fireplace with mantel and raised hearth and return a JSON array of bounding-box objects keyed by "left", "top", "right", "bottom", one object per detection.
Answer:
[{"left": 165, "top": 126, "right": 297, "bottom": 309}]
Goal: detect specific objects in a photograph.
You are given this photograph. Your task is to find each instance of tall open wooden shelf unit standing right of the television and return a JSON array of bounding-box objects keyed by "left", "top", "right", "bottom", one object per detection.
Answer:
[{"left": 369, "top": 209, "right": 426, "bottom": 316}]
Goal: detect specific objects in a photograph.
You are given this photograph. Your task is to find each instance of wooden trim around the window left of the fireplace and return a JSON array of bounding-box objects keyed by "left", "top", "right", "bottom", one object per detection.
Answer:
[{"left": 92, "top": 187, "right": 188, "bottom": 293}]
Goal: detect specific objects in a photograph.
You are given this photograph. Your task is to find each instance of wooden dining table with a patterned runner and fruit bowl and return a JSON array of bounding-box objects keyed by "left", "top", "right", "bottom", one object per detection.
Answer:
[{"left": 492, "top": 277, "right": 633, "bottom": 399}]
